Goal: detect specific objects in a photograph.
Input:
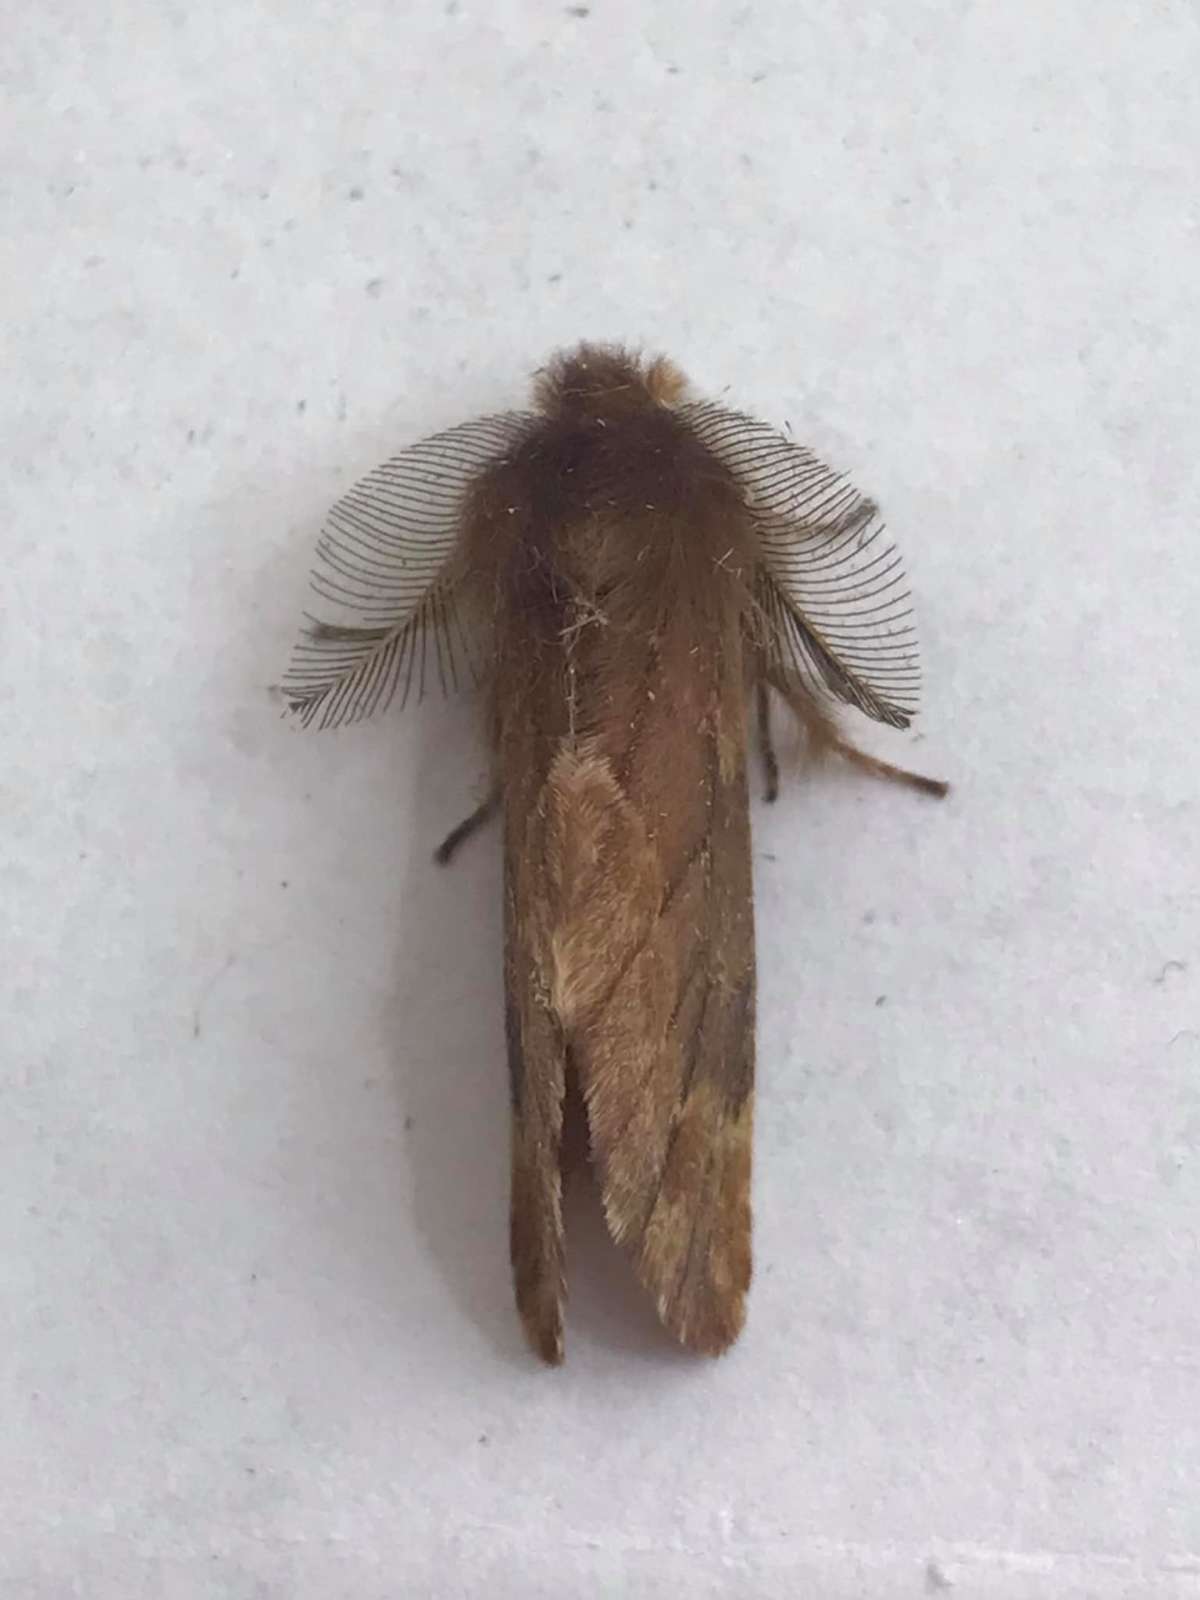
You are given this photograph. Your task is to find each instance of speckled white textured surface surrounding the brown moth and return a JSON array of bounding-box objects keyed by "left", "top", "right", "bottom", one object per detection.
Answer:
[{"left": 0, "top": 0, "right": 1200, "bottom": 1600}]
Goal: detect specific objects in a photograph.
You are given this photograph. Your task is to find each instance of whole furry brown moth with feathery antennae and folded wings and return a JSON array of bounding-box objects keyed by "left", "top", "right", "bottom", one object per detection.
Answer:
[{"left": 283, "top": 344, "right": 946, "bottom": 1363}]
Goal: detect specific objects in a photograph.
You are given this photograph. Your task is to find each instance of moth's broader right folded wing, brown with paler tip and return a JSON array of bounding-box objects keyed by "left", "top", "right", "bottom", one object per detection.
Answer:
[{"left": 544, "top": 635, "right": 754, "bottom": 1355}]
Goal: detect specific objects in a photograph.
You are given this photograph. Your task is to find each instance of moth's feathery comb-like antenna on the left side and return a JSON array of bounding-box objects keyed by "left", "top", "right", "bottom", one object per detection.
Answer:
[{"left": 282, "top": 411, "right": 534, "bottom": 728}]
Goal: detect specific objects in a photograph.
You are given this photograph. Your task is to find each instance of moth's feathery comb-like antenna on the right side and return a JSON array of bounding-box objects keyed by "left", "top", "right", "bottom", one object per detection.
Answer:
[{"left": 680, "top": 402, "right": 920, "bottom": 728}]
